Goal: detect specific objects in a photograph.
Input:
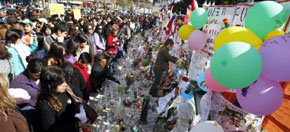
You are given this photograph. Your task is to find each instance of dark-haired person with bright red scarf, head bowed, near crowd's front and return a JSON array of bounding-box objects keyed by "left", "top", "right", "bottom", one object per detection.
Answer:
[{"left": 73, "top": 52, "right": 92, "bottom": 99}]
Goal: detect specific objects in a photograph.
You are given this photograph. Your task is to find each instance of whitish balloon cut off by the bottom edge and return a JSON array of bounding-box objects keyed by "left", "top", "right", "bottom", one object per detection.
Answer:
[{"left": 190, "top": 121, "right": 224, "bottom": 132}]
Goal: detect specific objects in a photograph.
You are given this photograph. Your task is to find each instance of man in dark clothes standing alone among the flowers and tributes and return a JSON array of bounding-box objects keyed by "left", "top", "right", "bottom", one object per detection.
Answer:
[{"left": 150, "top": 39, "right": 177, "bottom": 97}]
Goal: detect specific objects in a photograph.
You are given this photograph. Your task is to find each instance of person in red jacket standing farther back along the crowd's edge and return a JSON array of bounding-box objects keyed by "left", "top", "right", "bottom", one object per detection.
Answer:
[{"left": 107, "top": 30, "right": 119, "bottom": 57}]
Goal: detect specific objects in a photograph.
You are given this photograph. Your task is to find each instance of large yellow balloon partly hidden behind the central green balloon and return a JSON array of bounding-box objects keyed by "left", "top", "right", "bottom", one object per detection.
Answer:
[{"left": 214, "top": 27, "right": 263, "bottom": 51}]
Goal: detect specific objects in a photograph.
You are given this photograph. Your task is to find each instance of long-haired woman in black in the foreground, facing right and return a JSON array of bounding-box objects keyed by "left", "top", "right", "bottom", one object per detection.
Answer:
[{"left": 36, "top": 66, "right": 78, "bottom": 132}]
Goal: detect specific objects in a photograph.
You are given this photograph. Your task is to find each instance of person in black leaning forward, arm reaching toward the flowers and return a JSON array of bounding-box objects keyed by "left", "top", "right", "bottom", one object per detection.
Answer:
[{"left": 90, "top": 55, "right": 120, "bottom": 92}]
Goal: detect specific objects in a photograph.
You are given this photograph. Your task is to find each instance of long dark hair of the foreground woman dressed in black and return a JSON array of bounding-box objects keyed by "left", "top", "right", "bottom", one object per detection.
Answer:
[{"left": 38, "top": 66, "right": 65, "bottom": 111}]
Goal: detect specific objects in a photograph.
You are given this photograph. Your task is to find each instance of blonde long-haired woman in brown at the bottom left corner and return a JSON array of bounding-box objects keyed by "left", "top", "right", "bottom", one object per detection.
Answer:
[{"left": 0, "top": 73, "right": 29, "bottom": 132}]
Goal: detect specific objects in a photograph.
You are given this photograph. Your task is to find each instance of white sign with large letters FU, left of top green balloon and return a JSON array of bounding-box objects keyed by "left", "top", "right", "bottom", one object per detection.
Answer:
[{"left": 231, "top": 5, "right": 250, "bottom": 27}]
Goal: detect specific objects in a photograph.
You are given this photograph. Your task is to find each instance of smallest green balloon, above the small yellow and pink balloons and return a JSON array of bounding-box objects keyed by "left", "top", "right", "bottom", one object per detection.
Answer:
[{"left": 189, "top": 8, "right": 208, "bottom": 29}]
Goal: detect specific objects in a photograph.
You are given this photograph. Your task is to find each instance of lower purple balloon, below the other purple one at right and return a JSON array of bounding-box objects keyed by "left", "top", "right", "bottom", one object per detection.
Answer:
[{"left": 236, "top": 75, "right": 283, "bottom": 115}]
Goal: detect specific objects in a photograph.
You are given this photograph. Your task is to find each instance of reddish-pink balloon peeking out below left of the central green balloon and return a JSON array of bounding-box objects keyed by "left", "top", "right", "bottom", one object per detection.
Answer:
[{"left": 205, "top": 68, "right": 229, "bottom": 92}]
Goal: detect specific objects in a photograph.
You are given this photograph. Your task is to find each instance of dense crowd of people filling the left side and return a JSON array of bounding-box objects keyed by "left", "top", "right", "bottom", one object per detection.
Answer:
[{"left": 0, "top": 4, "right": 161, "bottom": 132}]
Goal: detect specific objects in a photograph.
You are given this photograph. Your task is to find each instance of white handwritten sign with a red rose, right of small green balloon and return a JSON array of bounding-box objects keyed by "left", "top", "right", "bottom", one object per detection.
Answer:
[{"left": 207, "top": 6, "right": 236, "bottom": 27}]
